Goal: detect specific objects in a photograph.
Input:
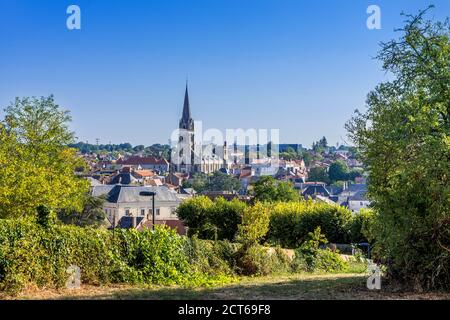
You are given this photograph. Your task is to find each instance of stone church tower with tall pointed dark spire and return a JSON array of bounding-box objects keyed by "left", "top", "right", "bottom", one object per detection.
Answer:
[{"left": 178, "top": 83, "right": 196, "bottom": 172}]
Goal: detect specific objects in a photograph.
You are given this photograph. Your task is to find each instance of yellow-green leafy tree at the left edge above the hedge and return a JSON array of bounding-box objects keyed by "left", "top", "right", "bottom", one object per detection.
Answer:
[{"left": 0, "top": 96, "right": 89, "bottom": 217}]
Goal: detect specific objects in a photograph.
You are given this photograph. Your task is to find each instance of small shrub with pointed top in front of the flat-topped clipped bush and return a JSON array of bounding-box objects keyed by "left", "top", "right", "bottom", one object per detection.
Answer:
[{"left": 293, "top": 227, "right": 348, "bottom": 272}]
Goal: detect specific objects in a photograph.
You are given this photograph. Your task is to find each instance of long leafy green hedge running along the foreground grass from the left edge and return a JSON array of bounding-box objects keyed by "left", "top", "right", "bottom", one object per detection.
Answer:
[{"left": 0, "top": 219, "right": 352, "bottom": 293}]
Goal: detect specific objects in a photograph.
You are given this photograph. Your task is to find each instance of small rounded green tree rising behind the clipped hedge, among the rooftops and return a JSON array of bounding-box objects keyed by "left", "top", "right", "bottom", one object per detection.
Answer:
[{"left": 253, "top": 176, "right": 300, "bottom": 202}]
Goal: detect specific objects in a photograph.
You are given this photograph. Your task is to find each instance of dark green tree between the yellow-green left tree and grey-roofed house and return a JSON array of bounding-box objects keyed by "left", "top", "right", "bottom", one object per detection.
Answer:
[{"left": 58, "top": 193, "right": 106, "bottom": 227}]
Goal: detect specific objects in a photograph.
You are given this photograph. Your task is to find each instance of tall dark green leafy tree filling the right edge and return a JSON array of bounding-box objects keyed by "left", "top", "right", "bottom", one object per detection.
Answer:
[{"left": 347, "top": 10, "right": 450, "bottom": 289}]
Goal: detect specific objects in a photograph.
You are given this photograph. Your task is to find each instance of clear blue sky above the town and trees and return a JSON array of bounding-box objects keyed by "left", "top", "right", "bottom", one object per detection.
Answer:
[{"left": 0, "top": 0, "right": 450, "bottom": 146}]
